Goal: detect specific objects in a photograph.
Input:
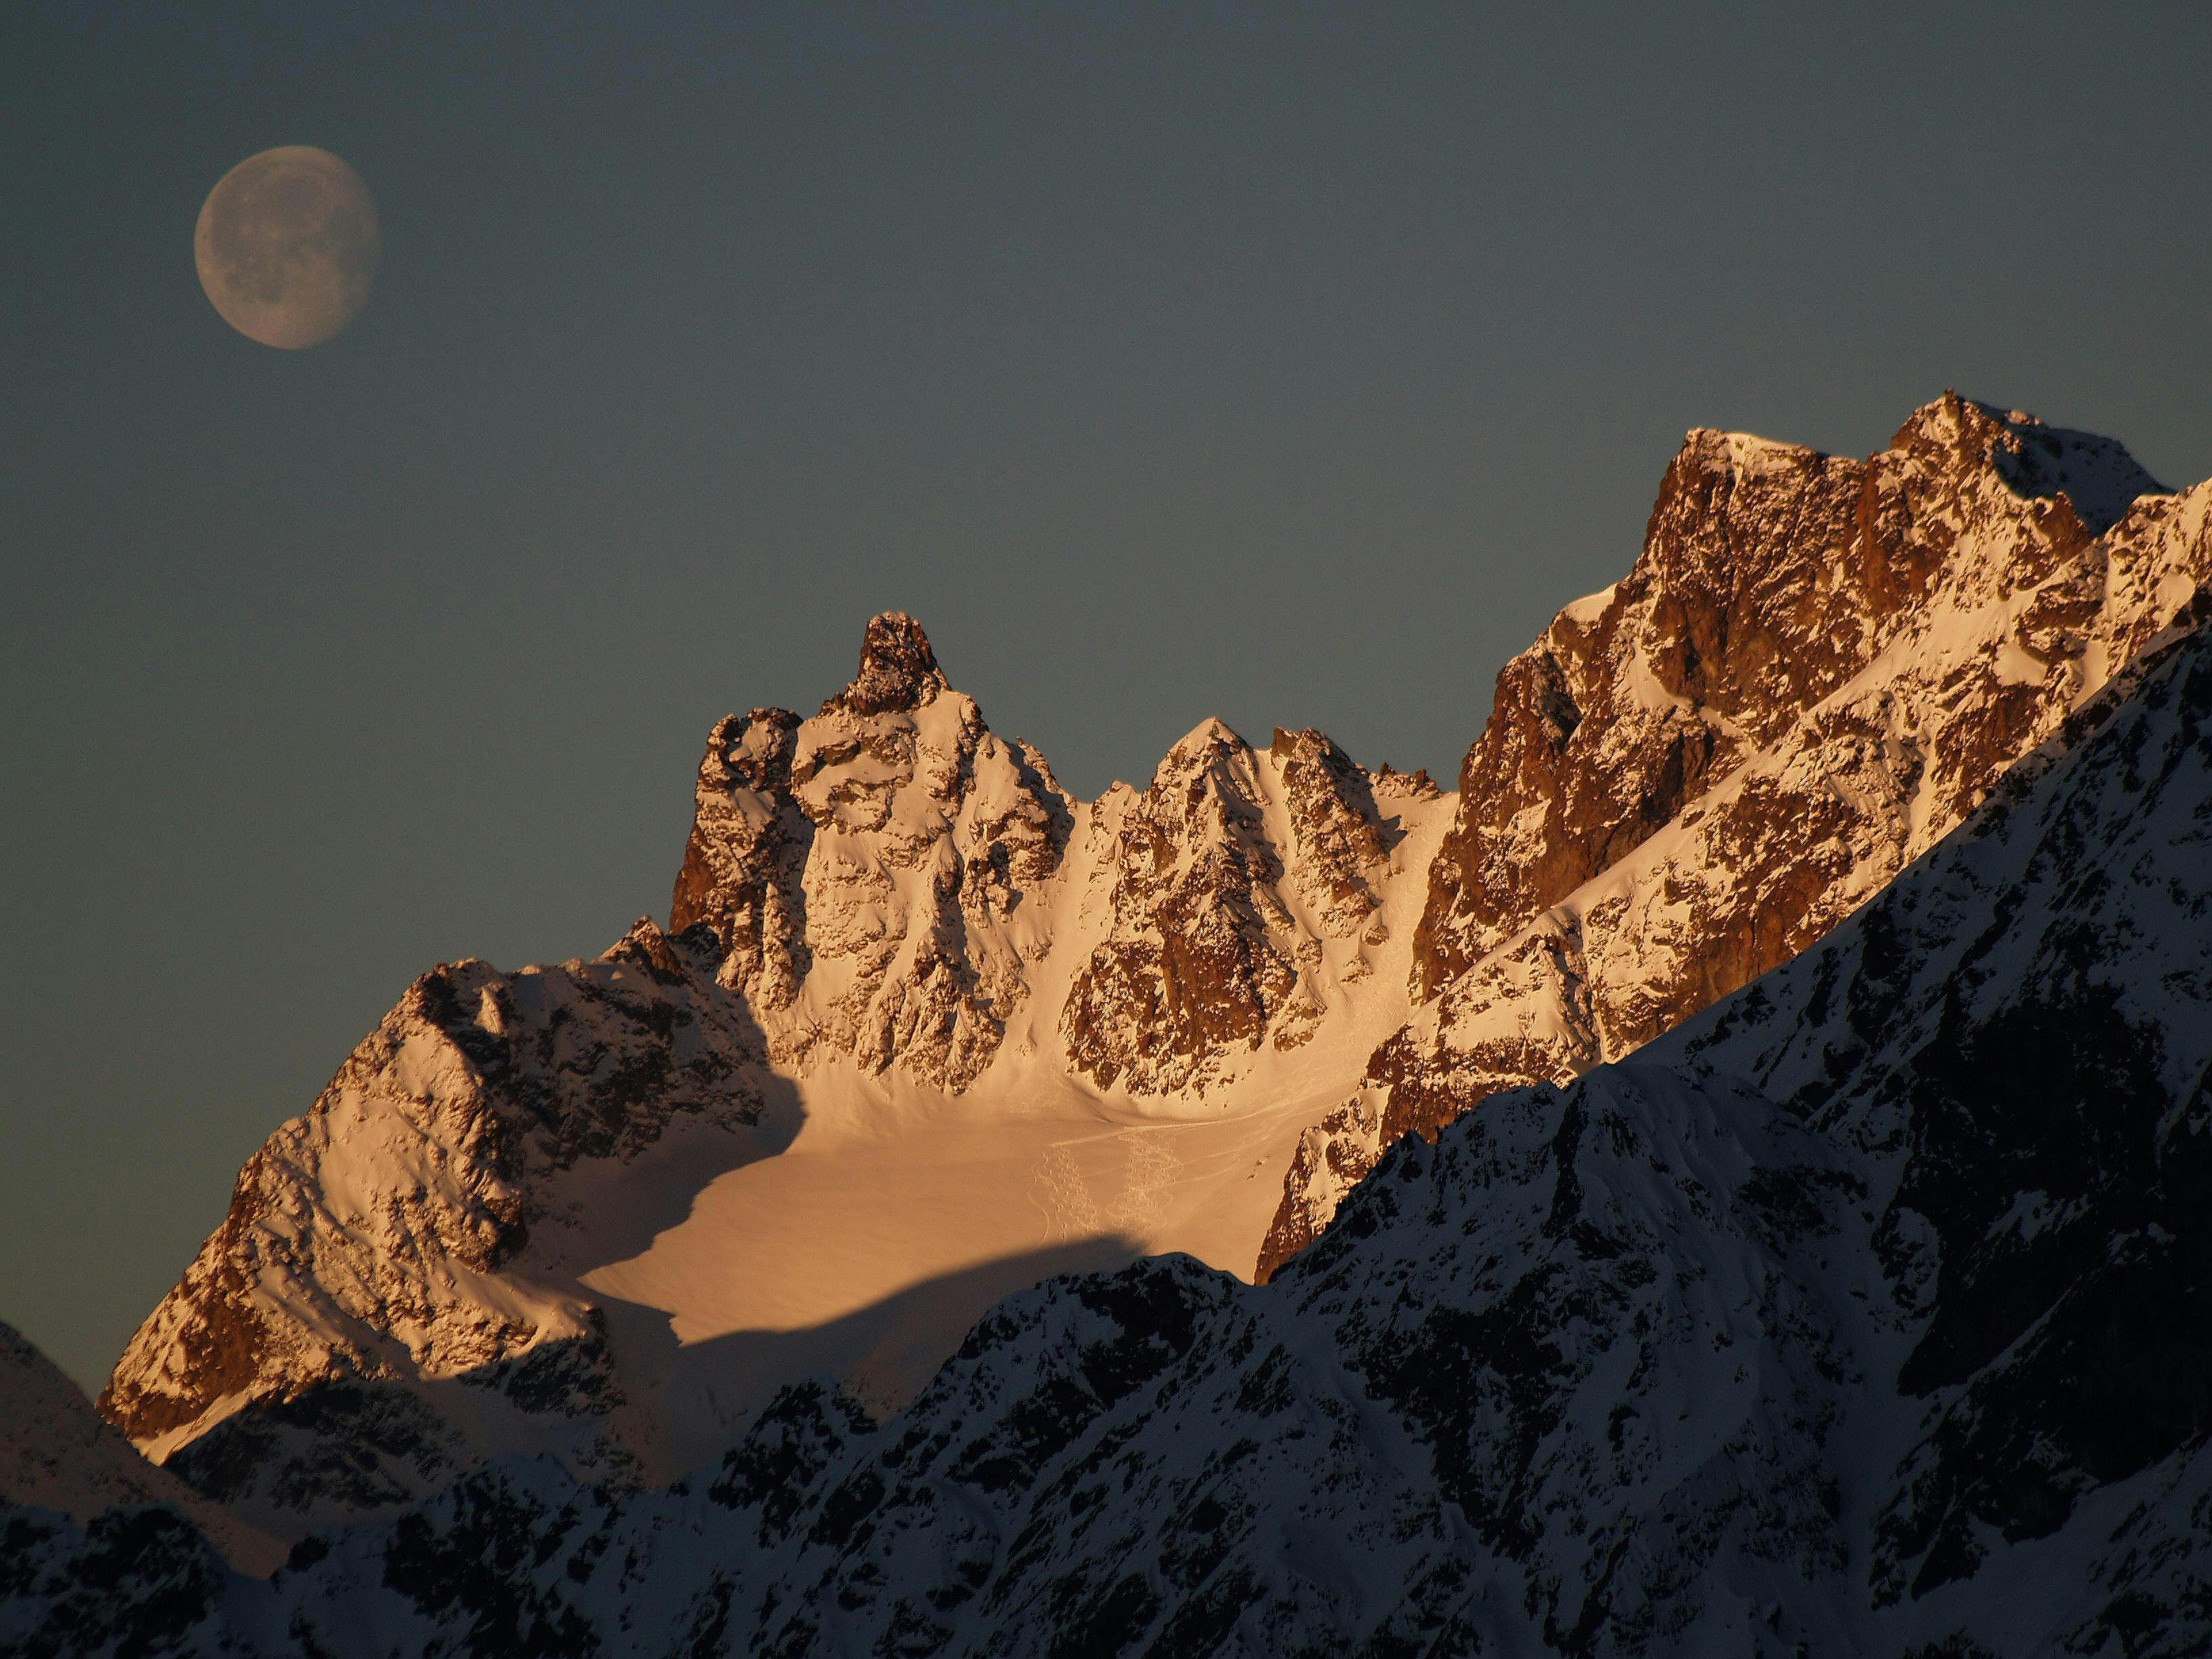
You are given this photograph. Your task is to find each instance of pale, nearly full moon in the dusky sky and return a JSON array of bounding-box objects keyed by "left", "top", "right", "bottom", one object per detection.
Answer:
[{"left": 192, "top": 144, "right": 383, "bottom": 352}]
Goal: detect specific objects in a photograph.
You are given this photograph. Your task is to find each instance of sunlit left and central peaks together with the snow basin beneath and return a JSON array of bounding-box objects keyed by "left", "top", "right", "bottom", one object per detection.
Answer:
[{"left": 102, "top": 615, "right": 1449, "bottom": 1535}]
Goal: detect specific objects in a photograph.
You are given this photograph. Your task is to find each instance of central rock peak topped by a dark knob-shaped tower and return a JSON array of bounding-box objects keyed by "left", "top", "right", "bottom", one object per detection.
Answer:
[{"left": 668, "top": 613, "right": 1071, "bottom": 1092}]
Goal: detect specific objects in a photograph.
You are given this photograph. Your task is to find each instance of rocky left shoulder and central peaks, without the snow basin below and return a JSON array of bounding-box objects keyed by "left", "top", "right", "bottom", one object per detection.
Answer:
[{"left": 102, "top": 615, "right": 1444, "bottom": 1535}]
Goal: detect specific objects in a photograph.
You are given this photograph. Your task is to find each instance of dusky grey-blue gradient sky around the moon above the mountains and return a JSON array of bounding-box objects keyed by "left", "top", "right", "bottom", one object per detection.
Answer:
[{"left": 0, "top": 0, "right": 2212, "bottom": 1387}]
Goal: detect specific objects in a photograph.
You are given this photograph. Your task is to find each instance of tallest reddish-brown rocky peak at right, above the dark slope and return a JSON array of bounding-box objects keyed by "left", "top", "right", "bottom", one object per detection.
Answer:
[{"left": 1258, "top": 396, "right": 2212, "bottom": 1274}]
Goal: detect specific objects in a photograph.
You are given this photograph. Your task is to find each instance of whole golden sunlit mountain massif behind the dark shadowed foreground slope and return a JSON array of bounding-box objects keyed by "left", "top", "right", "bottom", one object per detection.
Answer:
[{"left": 102, "top": 396, "right": 2212, "bottom": 1537}]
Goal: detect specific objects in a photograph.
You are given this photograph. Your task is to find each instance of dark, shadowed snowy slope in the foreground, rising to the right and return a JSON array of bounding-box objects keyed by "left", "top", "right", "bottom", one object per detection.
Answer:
[{"left": 17, "top": 517, "right": 2212, "bottom": 1659}]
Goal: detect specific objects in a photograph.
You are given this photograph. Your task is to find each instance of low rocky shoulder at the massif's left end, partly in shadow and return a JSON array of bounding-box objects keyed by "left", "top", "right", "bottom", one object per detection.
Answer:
[{"left": 100, "top": 920, "right": 761, "bottom": 1528}]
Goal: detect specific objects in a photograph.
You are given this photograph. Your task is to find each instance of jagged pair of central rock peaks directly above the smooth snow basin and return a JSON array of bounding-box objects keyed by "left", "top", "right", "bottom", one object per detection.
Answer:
[{"left": 670, "top": 613, "right": 1438, "bottom": 1095}]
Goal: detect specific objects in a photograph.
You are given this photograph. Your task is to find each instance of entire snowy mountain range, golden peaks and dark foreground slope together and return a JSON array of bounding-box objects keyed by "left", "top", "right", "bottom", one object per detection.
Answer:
[{"left": 13, "top": 394, "right": 2212, "bottom": 1659}]
